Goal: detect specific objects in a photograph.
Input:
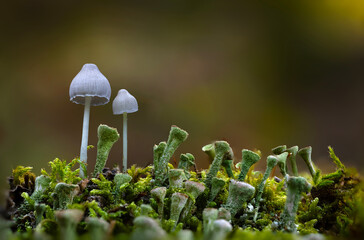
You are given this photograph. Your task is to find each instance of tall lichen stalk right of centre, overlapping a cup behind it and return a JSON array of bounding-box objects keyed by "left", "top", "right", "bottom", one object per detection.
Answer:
[{"left": 205, "top": 141, "right": 230, "bottom": 188}]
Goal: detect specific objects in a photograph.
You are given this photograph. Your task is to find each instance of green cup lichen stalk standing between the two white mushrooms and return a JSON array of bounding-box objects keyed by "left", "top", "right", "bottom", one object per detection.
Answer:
[{"left": 92, "top": 124, "right": 120, "bottom": 177}]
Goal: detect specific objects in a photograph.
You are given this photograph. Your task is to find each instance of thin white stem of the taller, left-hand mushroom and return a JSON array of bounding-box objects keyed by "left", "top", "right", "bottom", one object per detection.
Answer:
[{"left": 80, "top": 97, "right": 91, "bottom": 178}]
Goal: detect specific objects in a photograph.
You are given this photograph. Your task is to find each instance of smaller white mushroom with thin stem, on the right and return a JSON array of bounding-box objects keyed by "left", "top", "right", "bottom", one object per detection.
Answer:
[{"left": 112, "top": 89, "right": 138, "bottom": 172}]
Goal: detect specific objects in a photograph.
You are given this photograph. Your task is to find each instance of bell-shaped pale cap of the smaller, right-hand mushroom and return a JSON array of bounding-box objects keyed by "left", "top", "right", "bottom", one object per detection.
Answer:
[{"left": 112, "top": 89, "right": 138, "bottom": 115}]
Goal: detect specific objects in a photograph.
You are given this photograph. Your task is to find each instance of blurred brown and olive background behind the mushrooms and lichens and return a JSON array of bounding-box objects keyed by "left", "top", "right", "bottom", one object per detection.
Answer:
[{"left": 0, "top": 0, "right": 364, "bottom": 202}]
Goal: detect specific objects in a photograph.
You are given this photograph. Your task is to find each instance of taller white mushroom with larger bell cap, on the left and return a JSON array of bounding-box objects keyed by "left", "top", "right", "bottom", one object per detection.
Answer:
[{"left": 69, "top": 63, "right": 111, "bottom": 178}]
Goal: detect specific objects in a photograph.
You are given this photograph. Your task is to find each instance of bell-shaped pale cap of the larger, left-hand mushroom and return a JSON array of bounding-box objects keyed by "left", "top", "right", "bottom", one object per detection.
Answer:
[{"left": 70, "top": 63, "right": 111, "bottom": 106}]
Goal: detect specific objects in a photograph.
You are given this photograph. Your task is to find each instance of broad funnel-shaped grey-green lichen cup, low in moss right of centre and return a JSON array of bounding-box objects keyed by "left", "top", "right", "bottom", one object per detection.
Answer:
[{"left": 223, "top": 180, "right": 255, "bottom": 217}]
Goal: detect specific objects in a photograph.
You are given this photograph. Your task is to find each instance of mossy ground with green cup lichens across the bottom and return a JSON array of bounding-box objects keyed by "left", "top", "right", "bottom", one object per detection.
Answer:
[{"left": 0, "top": 127, "right": 364, "bottom": 240}]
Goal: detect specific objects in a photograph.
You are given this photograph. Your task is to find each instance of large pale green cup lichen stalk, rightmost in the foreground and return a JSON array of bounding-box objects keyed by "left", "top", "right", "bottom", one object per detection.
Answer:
[{"left": 280, "top": 176, "right": 311, "bottom": 232}]
